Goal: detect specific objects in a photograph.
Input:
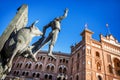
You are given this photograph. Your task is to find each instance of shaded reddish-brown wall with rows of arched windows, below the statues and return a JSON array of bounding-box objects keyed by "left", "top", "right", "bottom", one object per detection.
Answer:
[{"left": 8, "top": 51, "right": 70, "bottom": 80}]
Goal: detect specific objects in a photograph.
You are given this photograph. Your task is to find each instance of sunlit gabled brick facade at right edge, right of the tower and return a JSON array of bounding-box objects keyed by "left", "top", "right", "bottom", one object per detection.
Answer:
[{"left": 101, "top": 35, "right": 120, "bottom": 80}]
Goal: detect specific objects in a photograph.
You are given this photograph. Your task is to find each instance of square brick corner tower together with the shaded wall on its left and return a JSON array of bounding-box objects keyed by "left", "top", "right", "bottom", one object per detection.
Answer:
[{"left": 71, "top": 25, "right": 93, "bottom": 80}]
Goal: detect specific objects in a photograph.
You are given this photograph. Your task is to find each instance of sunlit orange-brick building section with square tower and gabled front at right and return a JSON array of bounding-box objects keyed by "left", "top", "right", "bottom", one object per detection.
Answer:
[{"left": 70, "top": 25, "right": 120, "bottom": 80}]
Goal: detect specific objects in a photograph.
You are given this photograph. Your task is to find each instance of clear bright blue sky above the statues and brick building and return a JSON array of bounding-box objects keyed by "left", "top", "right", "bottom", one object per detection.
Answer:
[{"left": 0, "top": 0, "right": 120, "bottom": 53}]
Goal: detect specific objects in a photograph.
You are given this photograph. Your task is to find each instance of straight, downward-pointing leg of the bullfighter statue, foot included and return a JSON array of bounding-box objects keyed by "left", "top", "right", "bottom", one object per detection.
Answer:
[{"left": 48, "top": 30, "right": 59, "bottom": 59}]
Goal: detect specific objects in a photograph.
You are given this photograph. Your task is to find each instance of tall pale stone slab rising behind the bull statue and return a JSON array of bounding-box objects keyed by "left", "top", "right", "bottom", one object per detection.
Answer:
[{"left": 0, "top": 4, "right": 28, "bottom": 79}]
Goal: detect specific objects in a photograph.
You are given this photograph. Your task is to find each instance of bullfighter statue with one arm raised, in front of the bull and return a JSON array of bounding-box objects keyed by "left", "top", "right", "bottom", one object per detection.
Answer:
[{"left": 34, "top": 8, "right": 68, "bottom": 59}]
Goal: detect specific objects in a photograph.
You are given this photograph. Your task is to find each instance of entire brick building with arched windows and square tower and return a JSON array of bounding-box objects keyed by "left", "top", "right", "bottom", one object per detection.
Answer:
[{"left": 7, "top": 29, "right": 120, "bottom": 80}]
